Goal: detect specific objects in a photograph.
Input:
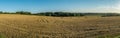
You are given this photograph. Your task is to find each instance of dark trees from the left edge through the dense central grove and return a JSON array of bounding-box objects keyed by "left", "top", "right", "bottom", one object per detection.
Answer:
[{"left": 0, "top": 11, "right": 84, "bottom": 17}]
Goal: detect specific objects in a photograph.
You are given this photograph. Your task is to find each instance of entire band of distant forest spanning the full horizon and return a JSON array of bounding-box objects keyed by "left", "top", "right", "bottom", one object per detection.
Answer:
[{"left": 0, "top": 11, "right": 120, "bottom": 17}]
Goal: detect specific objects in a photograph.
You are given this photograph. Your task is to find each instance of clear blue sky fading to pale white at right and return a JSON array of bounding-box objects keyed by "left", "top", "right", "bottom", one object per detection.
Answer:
[{"left": 0, "top": 0, "right": 120, "bottom": 13}]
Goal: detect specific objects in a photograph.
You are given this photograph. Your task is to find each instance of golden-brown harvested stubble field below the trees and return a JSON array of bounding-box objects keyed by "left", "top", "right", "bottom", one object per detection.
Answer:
[{"left": 0, "top": 14, "right": 120, "bottom": 38}]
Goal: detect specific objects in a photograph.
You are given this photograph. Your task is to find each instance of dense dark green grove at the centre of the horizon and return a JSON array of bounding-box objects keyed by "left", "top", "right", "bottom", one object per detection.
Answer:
[{"left": 35, "top": 12, "right": 84, "bottom": 17}]
